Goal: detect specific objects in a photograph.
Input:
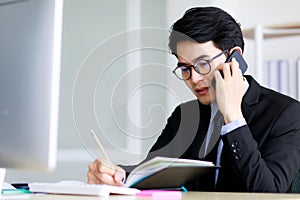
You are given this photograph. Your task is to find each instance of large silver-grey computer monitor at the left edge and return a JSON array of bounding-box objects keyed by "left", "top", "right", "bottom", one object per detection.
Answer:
[{"left": 0, "top": 0, "right": 63, "bottom": 171}]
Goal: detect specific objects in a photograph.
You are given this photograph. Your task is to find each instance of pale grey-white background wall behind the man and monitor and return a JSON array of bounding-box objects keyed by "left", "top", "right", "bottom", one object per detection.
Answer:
[{"left": 6, "top": 0, "right": 300, "bottom": 182}]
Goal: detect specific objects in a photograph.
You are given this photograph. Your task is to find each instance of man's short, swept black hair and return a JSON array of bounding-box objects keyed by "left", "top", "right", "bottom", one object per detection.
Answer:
[{"left": 169, "top": 7, "right": 244, "bottom": 56}]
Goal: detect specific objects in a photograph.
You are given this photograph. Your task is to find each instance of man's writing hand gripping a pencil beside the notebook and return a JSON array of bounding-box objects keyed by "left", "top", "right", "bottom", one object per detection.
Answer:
[{"left": 87, "top": 158, "right": 126, "bottom": 186}]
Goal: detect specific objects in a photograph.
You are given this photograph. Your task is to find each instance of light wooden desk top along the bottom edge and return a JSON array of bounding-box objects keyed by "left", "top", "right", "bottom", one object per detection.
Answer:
[{"left": 1, "top": 192, "right": 300, "bottom": 200}]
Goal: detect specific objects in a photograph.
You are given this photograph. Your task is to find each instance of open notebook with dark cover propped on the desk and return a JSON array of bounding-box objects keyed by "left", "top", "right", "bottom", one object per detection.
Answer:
[{"left": 126, "top": 157, "right": 219, "bottom": 189}]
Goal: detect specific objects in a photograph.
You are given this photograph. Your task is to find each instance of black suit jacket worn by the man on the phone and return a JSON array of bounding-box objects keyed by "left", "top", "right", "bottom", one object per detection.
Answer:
[{"left": 144, "top": 76, "right": 300, "bottom": 192}]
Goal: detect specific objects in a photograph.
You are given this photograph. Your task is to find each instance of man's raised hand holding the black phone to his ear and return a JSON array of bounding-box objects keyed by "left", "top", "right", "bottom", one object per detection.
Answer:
[{"left": 214, "top": 58, "right": 245, "bottom": 124}]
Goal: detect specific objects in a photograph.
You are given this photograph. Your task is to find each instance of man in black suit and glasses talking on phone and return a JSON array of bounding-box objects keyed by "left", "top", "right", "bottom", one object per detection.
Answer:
[{"left": 88, "top": 7, "right": 300, "bottom": 192}]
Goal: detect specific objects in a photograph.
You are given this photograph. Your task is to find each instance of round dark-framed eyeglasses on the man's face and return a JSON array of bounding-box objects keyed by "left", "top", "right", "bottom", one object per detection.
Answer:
[{"left": 172, "top": 50, "right": 227, "bottom": 80}]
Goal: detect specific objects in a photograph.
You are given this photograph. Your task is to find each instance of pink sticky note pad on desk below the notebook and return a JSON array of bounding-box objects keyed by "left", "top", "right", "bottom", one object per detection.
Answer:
[{"left": 136, "top": 190, "right": 182, "bottom": 200}]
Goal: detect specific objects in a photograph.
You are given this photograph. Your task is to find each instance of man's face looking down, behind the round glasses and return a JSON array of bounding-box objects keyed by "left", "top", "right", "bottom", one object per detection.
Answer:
[{"left": 177, "top": 40, "right": 226, "bottom": 105}]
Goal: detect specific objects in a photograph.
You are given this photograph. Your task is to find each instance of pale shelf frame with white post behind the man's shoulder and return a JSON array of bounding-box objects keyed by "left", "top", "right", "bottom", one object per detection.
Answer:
[{"left": 243, "top": 21, "right": 300, "bottom": 99}]
